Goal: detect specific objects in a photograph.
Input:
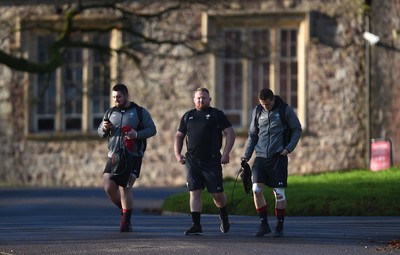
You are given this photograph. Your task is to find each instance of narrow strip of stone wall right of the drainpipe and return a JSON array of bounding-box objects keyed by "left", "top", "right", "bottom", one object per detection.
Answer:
[{"left": 371, "top": 0, "right": 400, "bottom": 165}]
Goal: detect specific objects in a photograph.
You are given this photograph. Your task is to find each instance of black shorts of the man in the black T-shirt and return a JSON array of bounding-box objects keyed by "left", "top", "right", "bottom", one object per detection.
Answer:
[{"left": 185, "top": 155, "right": 224, "bottom": 193}]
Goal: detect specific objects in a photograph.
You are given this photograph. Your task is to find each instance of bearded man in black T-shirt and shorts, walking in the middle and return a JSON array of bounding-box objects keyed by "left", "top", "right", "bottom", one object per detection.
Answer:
[{"left": 174, "top": 88, "right": 235, "bottom": 235}]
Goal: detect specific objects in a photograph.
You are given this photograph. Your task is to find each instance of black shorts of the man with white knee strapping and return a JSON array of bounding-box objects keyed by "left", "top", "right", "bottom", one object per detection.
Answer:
[{"left": 252, "top": 154, "right": 288, "bottom": 188}]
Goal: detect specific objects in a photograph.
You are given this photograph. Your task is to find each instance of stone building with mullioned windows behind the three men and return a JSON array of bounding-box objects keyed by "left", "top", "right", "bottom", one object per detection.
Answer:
[{"left": 0, "top": 0, "right": 400, "bottom": 186}]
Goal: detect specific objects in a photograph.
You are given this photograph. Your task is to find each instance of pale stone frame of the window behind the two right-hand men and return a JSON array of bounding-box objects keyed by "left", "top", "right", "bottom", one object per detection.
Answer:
[{"left": 202, "top": 12, "right": 309, "bottom": 135}]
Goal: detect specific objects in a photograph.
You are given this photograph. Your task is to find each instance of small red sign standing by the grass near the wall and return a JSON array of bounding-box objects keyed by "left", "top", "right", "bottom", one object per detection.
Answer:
[{"left": 369, "top": 140, "right": 392, "bottom": 171}]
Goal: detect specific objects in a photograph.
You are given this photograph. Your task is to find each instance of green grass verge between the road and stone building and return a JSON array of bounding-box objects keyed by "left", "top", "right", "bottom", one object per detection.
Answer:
[{"left": 162, "top": 168, "right": 400, "bottom": 216}]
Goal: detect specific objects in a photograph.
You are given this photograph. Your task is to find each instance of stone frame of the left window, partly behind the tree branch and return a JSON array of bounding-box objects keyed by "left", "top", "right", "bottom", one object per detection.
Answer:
[{"left": 20, "top": 19, "right": 120, "bottom": 139}]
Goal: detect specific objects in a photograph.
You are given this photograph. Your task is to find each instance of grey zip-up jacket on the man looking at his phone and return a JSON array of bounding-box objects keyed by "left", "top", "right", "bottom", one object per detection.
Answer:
[{"left": 97, "top": 102, "right": 157, "bottom": 158}]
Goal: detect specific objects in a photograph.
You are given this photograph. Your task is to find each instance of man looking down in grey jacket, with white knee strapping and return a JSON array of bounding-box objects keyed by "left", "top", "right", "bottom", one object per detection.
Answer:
[{"left": 242, "top": 89, "right": 302, "bottom": 237}]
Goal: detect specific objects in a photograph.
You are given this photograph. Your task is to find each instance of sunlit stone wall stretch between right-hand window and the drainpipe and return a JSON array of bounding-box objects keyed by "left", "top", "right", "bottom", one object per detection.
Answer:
[{"left": 276, "top": 1, "right": 365, "bottom": 174}]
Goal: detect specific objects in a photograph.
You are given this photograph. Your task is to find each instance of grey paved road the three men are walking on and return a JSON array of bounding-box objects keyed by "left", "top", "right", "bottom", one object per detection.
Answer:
[{"left": 0, "top": 188, "right": 400, "bottom": 255}]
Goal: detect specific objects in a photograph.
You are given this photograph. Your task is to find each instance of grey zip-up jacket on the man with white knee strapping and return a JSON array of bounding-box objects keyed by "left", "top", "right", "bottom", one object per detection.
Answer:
[{"left": 244, "top": 96, "right": 302, "bottom": 160}]
